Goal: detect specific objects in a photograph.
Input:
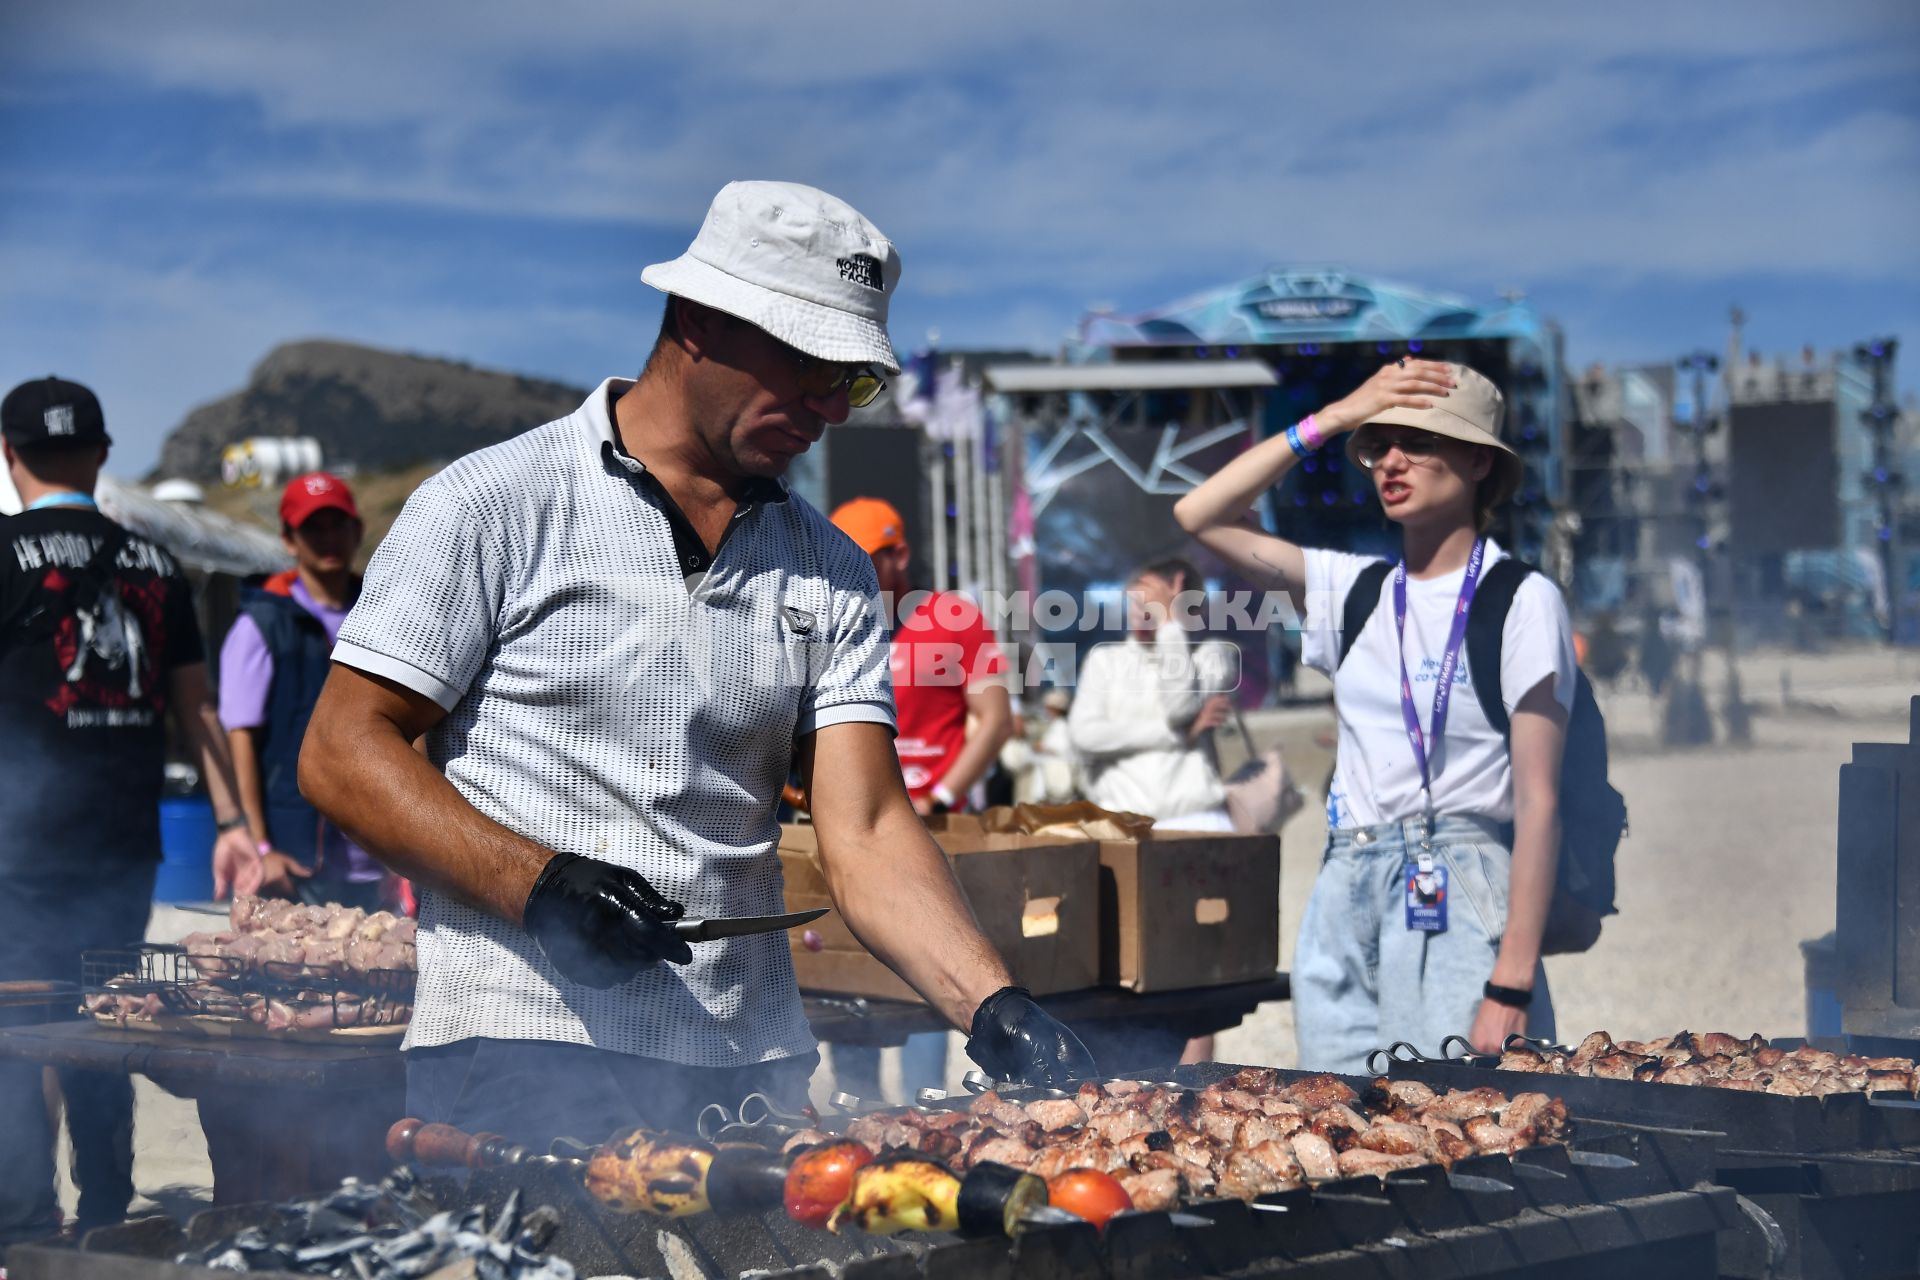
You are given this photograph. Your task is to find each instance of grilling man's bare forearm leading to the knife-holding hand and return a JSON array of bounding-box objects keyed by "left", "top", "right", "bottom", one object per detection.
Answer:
[{"left": 300, "top": 695, "right": 553, "bottom": 925}]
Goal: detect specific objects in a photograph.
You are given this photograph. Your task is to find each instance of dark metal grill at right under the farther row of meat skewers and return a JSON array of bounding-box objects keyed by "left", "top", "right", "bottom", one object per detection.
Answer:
[{"left": 1388, "top": 1038, "right": 1920, "bottom": 1280}]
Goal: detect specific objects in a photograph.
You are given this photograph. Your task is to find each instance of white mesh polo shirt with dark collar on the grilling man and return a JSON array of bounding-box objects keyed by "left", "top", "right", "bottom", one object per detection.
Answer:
[{"left": 334, "top": 380, "right": 893, "bottom": 1067}]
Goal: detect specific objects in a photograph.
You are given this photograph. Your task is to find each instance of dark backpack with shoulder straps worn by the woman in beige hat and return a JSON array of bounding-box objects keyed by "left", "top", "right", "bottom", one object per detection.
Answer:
[{"left": 1340, "top": 558, "right": 1626, "bottom": 956}]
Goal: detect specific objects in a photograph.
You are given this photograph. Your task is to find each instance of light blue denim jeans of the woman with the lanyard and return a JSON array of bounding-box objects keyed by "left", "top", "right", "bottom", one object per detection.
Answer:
[{"left": 1292, "top": 816, "right": 1553, "bottom": 1073}]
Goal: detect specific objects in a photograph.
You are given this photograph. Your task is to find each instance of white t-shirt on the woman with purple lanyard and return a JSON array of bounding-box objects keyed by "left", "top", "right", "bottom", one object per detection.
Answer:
[{"left": 1300, "top": 539, "right": 1574, "bottom": 827}]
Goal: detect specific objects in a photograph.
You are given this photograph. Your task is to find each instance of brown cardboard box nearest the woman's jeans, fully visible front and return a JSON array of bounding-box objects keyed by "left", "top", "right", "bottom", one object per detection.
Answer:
[{"left": 1100, "top": 831, "right": 1281, "bottom": 992}]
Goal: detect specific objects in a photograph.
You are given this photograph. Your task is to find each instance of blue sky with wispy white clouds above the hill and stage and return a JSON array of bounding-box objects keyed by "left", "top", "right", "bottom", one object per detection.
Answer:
[{"left": 0, "top": 0, "right": 1920, "bottom": 476}]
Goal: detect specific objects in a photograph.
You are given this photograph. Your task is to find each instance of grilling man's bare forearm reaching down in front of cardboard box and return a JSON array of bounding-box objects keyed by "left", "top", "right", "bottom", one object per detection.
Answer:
[{"left": 816, "top": 804, "right": 1012, "bottom": 1031}]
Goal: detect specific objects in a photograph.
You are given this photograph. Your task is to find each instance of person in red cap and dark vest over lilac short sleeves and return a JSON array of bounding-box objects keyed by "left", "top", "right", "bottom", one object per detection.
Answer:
[{"left": 221, "top": 472, "right": 386, "bottom": 910}]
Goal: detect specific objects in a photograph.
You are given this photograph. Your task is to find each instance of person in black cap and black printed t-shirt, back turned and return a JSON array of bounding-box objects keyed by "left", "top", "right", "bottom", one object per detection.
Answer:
[{"left": 0, "top": 378, "right": 259, "bottom": 1247}]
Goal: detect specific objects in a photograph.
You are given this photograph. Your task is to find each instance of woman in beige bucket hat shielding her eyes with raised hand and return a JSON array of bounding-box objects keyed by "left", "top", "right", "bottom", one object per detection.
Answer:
[{"left": 1173, "top": 359, "right": 1574, "bottom": 1071}]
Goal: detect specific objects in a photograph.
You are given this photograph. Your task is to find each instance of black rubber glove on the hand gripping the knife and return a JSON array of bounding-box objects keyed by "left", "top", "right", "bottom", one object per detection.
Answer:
[{"left": 524, "top": 854, "right": 693, "bottom": 988}]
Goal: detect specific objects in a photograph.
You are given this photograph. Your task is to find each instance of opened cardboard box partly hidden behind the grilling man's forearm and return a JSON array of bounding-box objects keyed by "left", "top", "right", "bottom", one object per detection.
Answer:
[{"left": 780, "top": 825, "right": 1100, "bottom": 1002}]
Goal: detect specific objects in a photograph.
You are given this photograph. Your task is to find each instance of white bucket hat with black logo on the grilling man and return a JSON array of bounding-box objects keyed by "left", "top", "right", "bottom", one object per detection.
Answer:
[{"left": 639, "top": 182, "right": 900, "bottom": 374}]
